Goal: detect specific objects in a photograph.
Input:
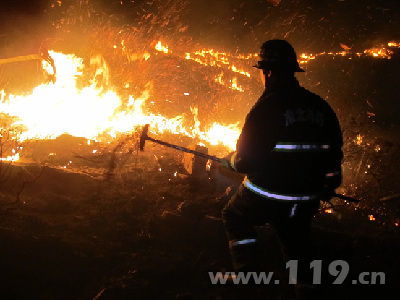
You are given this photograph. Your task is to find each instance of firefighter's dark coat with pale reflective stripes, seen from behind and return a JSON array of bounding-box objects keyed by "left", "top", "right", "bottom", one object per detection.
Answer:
[{"left": 230, "top": 77, "right": 343, "bottom": 201}]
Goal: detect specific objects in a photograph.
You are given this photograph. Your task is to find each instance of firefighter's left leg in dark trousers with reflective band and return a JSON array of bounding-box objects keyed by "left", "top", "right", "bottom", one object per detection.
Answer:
[{"left": 222, "top": 186, "right": 258, "bottom": 272}]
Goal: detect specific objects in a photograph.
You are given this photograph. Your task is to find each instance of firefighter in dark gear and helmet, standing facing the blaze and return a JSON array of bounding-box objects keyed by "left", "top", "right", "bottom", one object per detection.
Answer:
[{"left": 222, "top": 40, "right": 343, "bottom": 282}]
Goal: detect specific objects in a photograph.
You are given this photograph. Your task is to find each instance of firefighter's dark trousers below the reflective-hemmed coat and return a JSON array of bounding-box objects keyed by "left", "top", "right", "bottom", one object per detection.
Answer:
[{"left": 222, "top": 184, "right": 319, "bottom": 279}]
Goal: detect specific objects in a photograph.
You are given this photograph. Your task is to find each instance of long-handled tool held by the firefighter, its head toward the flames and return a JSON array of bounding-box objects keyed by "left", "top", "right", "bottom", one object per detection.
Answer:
[{"left": 139, "top": 124, "right": 360, "bottom": 203}]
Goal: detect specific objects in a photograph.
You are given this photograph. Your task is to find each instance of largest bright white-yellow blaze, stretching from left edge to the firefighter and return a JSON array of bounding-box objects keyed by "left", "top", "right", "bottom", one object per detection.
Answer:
[{"left": 0, "top": 51, "right": 240, "bottom": 161}]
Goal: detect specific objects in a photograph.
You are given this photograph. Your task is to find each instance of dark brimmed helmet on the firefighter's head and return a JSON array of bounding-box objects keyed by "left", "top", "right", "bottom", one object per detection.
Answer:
[{"left": 254, "top": 40, "right": 305, "bottom": 72}]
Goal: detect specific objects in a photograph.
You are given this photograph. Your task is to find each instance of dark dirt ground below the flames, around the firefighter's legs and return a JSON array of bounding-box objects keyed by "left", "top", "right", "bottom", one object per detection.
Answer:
[{"left": 0, "top": 148, "right": 400, "bottom": 300}]
